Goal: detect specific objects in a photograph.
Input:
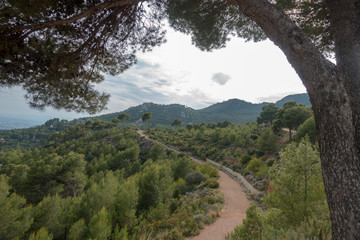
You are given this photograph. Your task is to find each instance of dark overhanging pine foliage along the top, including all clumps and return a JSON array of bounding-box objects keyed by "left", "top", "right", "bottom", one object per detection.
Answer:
[{"left": 0, "top": 0, "right": 333, "bottom": 113}]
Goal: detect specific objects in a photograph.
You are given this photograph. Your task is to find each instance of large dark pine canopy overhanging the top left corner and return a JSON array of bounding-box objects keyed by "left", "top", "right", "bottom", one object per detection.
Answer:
[{"left": 0, "top": 0, "right": 164, "bottom": 113}]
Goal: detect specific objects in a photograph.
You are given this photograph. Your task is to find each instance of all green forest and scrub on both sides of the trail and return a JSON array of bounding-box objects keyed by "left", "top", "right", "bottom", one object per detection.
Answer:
[{"left": 0, "top": 102, "right": 331, "bottom": 240}]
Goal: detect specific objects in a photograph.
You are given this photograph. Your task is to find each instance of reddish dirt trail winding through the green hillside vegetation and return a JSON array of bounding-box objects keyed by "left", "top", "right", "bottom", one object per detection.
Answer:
[{"left": 138, "top": 130, "right": 251, "bottom": 240}]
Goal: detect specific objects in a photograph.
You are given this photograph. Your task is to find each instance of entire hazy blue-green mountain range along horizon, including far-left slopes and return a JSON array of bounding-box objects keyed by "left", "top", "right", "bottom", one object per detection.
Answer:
[{"left": 0, "top": 94, "right": 310, "bottom": 150}]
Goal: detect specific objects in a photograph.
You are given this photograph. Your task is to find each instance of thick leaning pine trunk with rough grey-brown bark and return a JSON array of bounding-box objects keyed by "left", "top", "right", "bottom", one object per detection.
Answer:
[{"left": 228, "top": 0, "right": 360, "bottom": 240}]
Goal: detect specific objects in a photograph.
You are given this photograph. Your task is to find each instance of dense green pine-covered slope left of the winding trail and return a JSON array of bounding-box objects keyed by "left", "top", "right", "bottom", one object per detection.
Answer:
[{"left": 0, "top": 121, "right": 223, "bottom": 240}]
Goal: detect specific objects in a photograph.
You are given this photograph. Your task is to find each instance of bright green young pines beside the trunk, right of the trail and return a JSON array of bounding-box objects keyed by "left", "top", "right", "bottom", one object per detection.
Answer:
[{"left": 227, "top": 139, "right": 331, "bottom": 240}]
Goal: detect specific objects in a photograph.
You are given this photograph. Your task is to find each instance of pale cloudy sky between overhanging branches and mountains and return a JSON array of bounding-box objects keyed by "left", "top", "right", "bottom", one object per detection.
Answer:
[{"left": 0, "top": 29, "right": 305, "bottom": 121}]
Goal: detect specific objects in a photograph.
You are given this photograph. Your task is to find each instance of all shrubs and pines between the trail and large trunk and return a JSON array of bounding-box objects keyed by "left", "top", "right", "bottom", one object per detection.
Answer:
[{"left": 148, "top": 102, "right": 331, "bottom": 240}]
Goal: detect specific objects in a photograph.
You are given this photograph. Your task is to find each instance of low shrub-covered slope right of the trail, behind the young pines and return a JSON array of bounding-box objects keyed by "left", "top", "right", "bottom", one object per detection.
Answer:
[{"left": 147, "top": 121, "right": 284, "bottom": 190}]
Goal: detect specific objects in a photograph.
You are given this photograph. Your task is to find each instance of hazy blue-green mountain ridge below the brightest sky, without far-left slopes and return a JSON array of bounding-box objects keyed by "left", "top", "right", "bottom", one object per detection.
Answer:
[{"left": 82, "top": 93, "right": 311, "bottom": 126}]
